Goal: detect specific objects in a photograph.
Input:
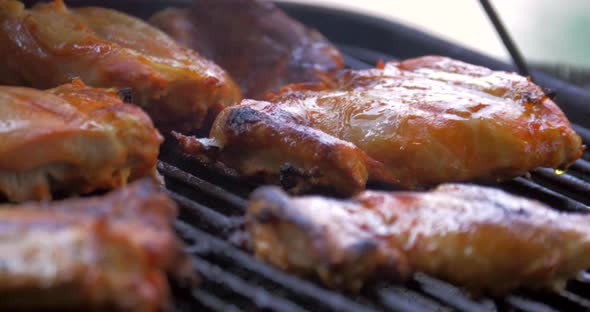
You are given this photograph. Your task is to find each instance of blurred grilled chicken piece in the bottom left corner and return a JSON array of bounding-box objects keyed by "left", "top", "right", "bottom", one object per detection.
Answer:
[{"left": 0, "top": 181, "right": 186, "bottom": 311}]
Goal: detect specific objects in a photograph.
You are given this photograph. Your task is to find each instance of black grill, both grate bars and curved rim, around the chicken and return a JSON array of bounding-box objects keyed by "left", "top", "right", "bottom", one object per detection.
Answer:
[{"left": 35, "top": 0, "right": 590, "bottom": 311}]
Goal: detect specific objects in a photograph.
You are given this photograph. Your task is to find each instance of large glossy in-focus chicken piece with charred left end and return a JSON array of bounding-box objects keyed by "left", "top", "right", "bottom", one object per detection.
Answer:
[{"left": 177, "top": 56, "right": 584, "bottom": 194}]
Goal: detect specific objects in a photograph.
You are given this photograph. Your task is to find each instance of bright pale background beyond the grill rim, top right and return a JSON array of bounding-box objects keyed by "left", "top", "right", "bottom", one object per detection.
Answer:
[{"left": 279, "top": 0, "right": 590, "bottom": 67}]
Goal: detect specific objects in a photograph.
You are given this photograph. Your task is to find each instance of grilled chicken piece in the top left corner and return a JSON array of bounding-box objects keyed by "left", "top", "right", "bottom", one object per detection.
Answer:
[{"left": 0, "top": 0, "right": 241, "bottom": 131}]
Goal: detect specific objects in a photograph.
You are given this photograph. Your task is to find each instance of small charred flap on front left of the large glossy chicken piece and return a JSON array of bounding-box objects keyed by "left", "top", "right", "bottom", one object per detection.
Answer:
[{"left": 172, "top": 100, "right": 396, "bottom": 195}]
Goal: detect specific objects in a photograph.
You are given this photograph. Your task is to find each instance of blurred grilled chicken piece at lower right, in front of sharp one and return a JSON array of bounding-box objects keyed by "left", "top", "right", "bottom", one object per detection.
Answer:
[{"left": 247, "top": 184, "right": 590, "bottom": 295}]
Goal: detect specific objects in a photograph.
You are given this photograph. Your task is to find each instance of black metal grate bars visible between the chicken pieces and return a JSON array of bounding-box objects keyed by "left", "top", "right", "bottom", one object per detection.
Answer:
[{"left": 158, "top": 49, "right": 590, "bottom": 312}]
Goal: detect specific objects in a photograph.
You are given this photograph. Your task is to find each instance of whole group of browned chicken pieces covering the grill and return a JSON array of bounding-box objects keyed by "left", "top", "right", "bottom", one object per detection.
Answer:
[{"left": 0, "top": 0, "right": 590, "bottom": 311}]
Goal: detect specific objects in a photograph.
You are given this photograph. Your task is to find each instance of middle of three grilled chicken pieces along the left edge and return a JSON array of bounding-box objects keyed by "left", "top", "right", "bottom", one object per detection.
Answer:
[{"left": 0, "top": 80, "right": 162, "bottom": 202}]
